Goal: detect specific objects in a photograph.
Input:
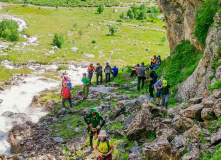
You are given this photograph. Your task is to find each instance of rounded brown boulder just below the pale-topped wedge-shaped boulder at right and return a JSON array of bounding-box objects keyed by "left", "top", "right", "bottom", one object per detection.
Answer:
[{"left": 175, "top": 117, "right": 194, "bottom": 132}]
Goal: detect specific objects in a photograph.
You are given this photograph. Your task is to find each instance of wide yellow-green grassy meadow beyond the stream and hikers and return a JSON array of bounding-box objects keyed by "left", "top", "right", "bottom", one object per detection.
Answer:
[{"left": 0, "top": 6, "right": 169, "bottom": 66}]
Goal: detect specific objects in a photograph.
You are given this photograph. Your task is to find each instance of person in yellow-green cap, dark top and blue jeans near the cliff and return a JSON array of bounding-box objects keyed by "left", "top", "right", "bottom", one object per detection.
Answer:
[{"left": 162, "top": 80, "right": 173, "bottom": 108}]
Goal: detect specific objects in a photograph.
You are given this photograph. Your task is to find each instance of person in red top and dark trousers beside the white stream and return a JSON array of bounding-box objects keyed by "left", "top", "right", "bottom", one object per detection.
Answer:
[{"left": 60, "top": 82, "right": 72, "bottom": 109}]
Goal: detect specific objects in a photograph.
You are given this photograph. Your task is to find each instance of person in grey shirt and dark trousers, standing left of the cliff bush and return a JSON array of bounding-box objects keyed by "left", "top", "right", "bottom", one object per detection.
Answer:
[{"left": 137, "top": 62, "right": 147, "bottom": 91}]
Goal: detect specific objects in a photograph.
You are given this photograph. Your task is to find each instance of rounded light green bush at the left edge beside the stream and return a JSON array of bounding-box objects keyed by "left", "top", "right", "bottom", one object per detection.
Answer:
[{"left": 0, "top": 20, "right": 19, "bottom": 42}]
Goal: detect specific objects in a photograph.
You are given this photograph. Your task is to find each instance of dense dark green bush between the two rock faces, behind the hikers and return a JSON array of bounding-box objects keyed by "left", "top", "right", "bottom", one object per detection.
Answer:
[{"left": 156, "top": 41, "right": 203, "bottom": 90}]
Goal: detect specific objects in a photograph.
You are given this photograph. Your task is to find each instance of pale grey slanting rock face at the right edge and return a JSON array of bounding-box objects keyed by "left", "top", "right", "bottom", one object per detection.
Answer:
[{"left": 174, "top": 12, "right": 221, "bottom": 101}]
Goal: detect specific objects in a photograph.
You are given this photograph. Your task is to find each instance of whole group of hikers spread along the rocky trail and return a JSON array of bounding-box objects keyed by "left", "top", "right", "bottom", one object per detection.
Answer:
[{"left": 60, "top": 55, "right": 173, "bottom": 160}]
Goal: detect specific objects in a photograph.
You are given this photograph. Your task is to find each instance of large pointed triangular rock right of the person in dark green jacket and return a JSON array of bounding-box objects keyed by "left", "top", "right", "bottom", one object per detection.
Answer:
[{"left": 126, "top": 105, "right": 154, "bottom": 140}]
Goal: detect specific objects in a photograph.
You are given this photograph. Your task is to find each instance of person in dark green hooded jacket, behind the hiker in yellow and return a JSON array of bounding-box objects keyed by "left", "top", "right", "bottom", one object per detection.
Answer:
[{"left": 84, "top": 108, "right": 105, "bottom": 151}]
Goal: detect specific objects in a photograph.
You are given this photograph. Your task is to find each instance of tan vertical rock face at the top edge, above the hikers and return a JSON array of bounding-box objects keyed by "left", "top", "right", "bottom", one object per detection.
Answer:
[{"left": 157, "top": 0, "right": 203, "bottom": 51}]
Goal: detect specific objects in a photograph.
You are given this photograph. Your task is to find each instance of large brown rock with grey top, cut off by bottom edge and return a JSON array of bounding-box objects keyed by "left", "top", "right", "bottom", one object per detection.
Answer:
[{"left": 142, "top": 137, "right": 180, "bottom": 160}]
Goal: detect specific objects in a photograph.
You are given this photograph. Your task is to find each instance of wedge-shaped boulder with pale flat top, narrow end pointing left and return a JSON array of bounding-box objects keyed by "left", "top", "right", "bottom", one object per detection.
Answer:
[{"left": 180, "top": 104, "right": 203, "bottom": 120}]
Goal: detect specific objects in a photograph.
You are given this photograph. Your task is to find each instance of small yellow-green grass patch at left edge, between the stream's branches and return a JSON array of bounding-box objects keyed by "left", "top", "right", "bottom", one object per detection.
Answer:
[{"left": 0, "top": 66, "right": 33, "bottom": 82}]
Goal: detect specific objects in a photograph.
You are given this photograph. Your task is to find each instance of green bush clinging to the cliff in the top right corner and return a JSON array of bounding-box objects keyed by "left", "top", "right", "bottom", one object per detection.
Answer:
[{"left": 194, "top": 0, "right": 221, "bottom": 44}]
